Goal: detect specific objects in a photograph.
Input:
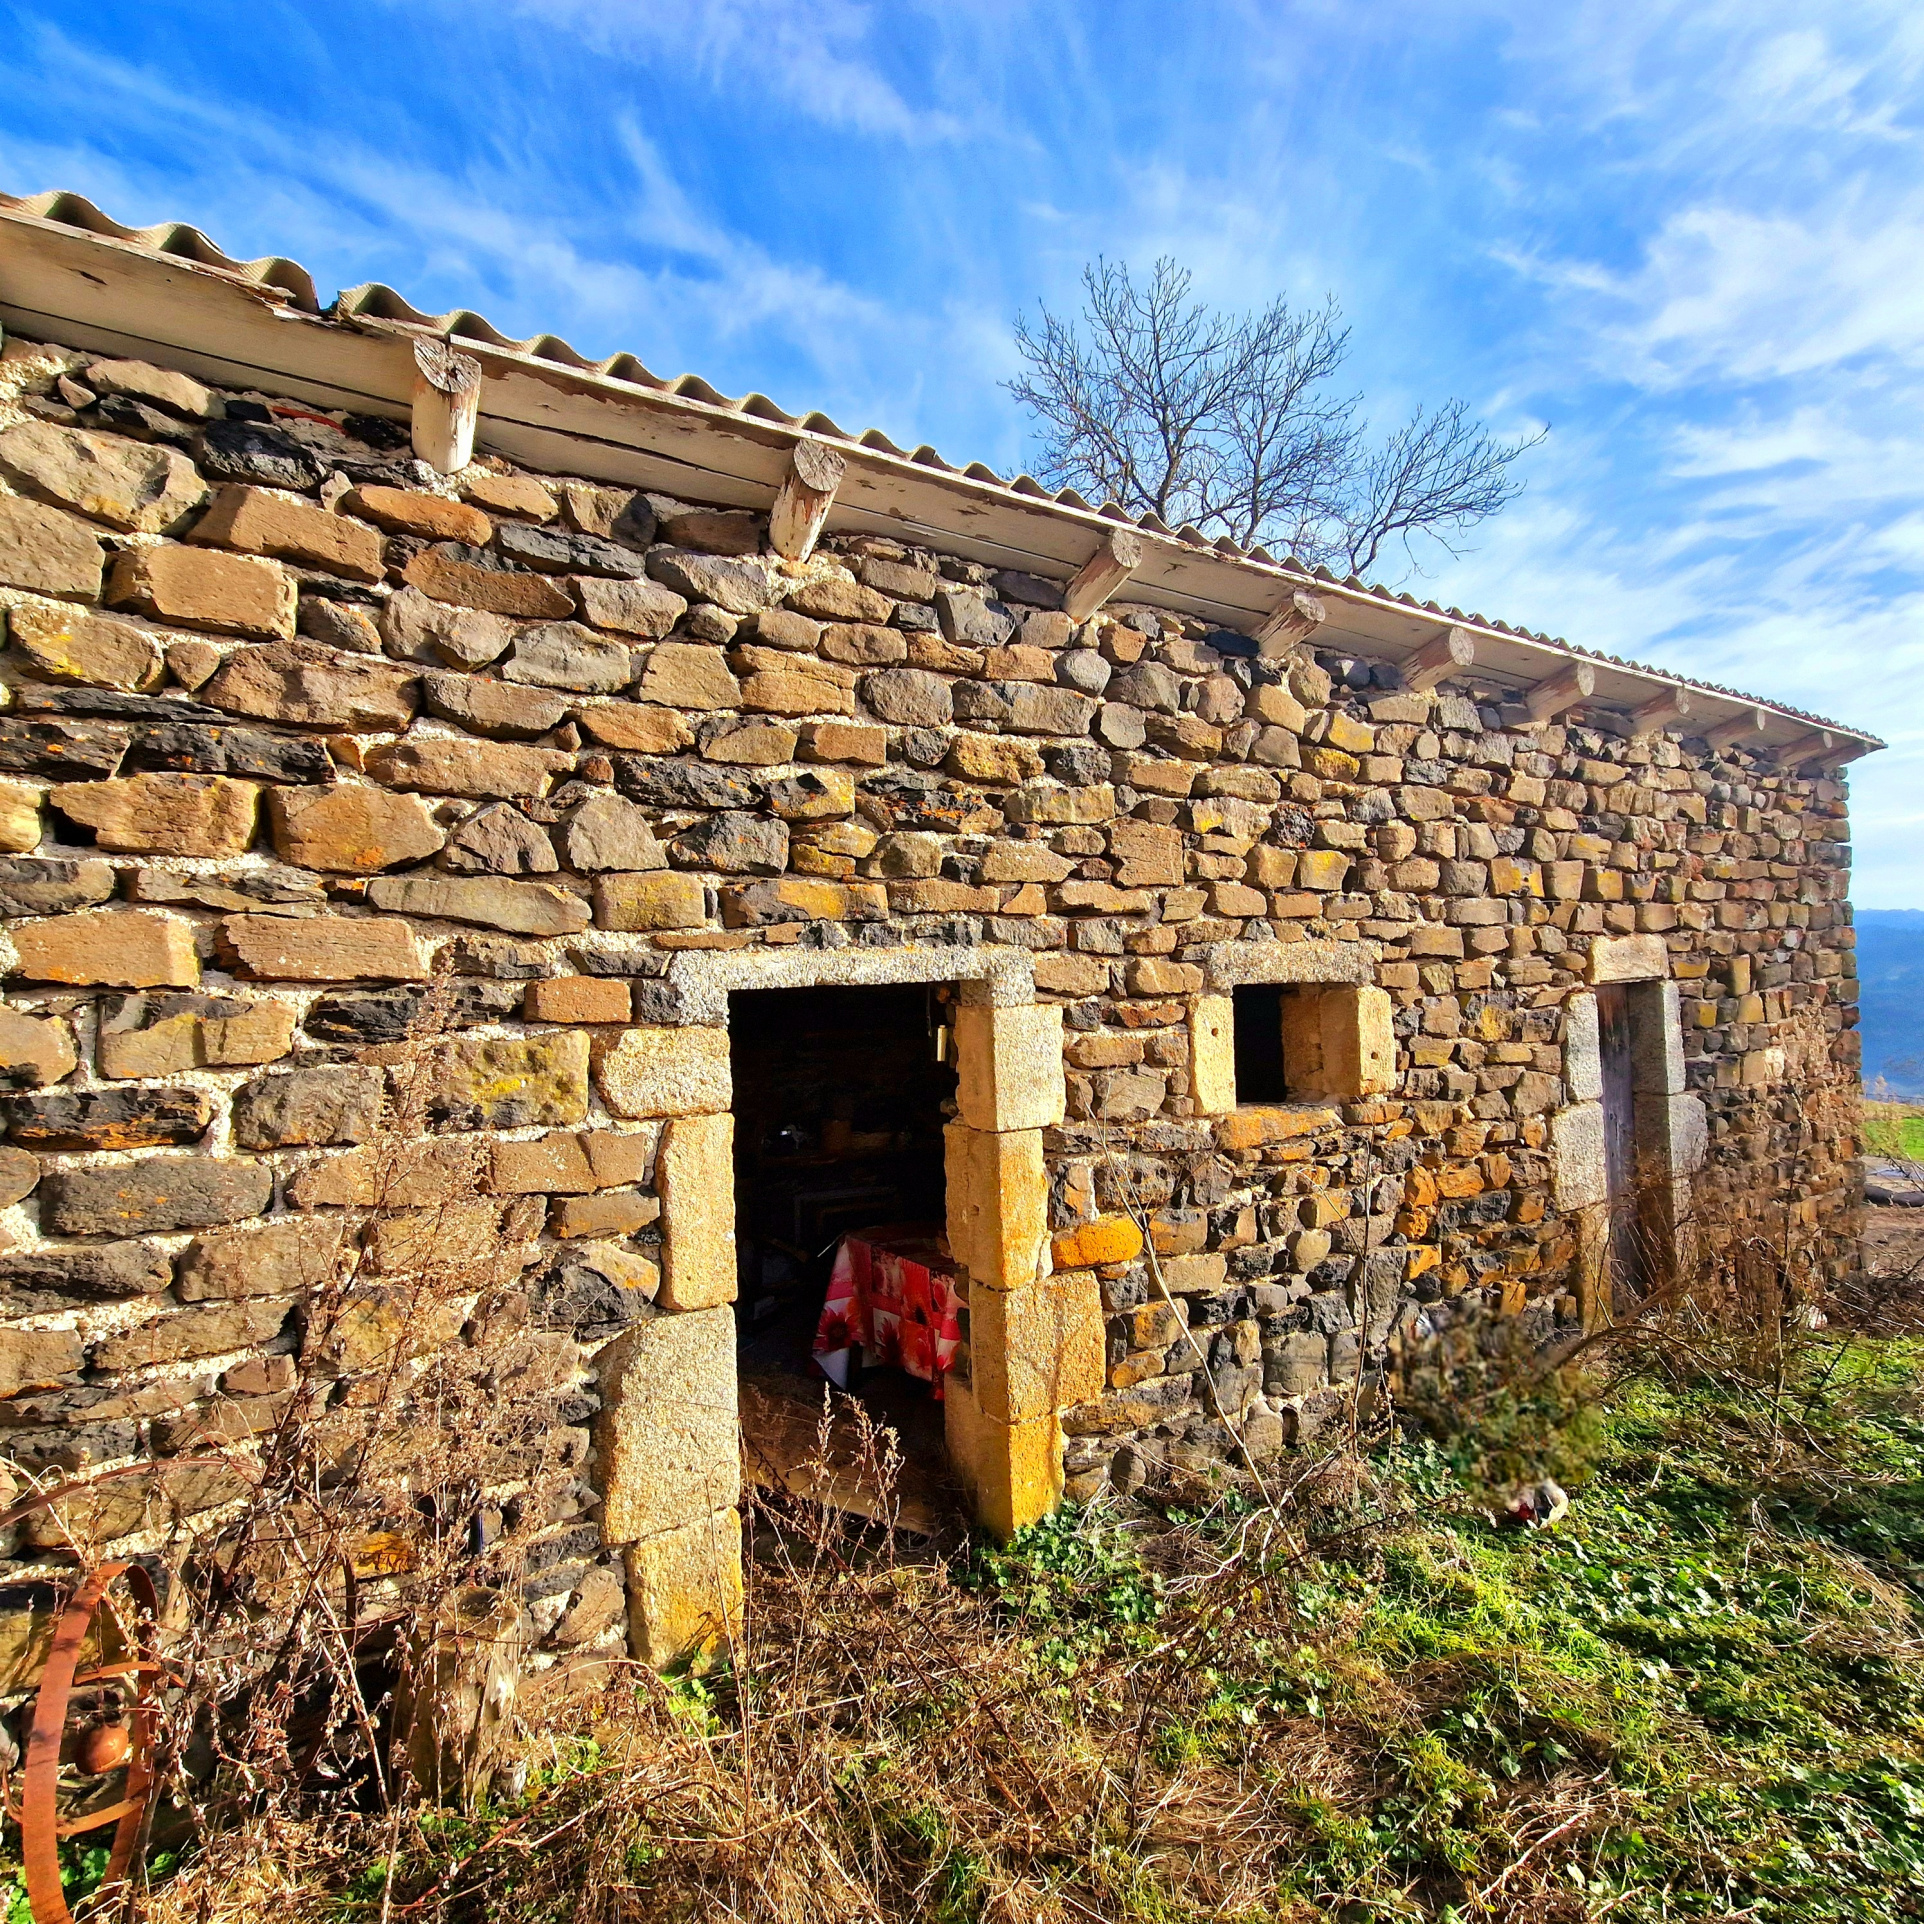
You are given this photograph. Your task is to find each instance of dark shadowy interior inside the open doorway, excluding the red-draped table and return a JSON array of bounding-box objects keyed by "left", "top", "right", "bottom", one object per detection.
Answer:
[{"left": 716, "top": 985, "right": 956, "bottom": 1522}]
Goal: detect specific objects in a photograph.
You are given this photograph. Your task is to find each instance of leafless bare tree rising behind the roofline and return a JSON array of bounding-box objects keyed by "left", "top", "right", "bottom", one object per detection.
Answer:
[{"left": 1006, "top": 258, "right": 1543, "bottom": 573}]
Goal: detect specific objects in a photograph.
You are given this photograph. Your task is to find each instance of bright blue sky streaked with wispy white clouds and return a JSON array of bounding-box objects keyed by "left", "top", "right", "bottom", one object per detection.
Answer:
[{"left": 0, "top": 0, "right": 1924, "bottom": 908}]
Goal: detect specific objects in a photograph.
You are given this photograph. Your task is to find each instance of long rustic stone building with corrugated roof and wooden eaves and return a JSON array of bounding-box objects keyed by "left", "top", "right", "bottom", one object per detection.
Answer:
[{"left": 0, "top": 196, "right": 1878, "bottom": 1658}]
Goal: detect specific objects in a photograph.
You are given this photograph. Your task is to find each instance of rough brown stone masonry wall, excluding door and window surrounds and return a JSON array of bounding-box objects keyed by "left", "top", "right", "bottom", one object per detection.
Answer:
[{"left": 0, "top": 330, "right": 1855, "bottom": 1643}]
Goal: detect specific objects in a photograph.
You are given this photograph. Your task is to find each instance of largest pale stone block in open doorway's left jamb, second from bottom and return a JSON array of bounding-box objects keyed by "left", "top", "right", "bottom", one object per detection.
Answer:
[{"left": 596, "top": 1306, "right": 741, "bottom": 1543}]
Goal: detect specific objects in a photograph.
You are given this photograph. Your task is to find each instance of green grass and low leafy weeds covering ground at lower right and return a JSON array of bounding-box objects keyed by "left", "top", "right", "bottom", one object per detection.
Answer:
[{"left": 991, "top": 1345, "right": 1924, "bottom": 1924}]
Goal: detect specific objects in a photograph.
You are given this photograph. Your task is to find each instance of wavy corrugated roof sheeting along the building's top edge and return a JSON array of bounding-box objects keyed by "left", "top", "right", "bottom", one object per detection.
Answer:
[{"left": 0, "top": 190, "right": 1884, "bottom": 748}]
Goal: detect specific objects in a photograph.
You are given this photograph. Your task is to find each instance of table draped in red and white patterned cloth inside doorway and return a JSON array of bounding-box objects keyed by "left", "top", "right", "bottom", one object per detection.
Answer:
[{"left": 814, "top": 1222, "right": 962, "bottom": 1401}]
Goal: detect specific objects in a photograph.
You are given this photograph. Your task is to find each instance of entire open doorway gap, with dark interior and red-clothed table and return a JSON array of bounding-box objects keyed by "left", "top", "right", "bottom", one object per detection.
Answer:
[{"left": 716, "top": 983, "right": 956, "bottom": 1533}]
